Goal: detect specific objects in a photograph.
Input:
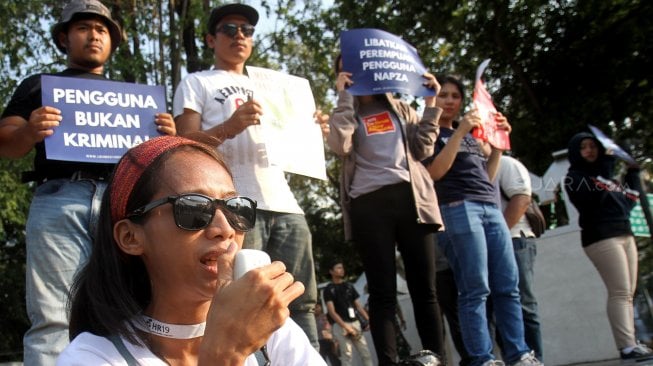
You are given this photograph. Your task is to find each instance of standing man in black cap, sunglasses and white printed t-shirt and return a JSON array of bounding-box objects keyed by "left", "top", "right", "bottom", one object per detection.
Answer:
[{"left": 173, "top": 4, "right": 319, "bottom": 348}]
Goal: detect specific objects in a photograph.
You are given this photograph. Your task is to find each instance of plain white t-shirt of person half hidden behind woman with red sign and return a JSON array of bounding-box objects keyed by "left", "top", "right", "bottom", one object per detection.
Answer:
[{"left": 497, "top": 155, "right": 535, "bottom": 238}]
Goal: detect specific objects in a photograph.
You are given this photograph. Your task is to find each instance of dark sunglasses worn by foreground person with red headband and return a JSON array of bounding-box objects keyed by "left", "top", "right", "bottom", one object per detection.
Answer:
[{"left": 127, "top": 193, "right": 256, "bottom": 231}]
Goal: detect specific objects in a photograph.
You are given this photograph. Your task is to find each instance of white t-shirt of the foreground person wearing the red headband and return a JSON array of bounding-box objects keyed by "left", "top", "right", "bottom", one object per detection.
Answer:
[{"left": 57, "top": 319, "right": 326, "bottom": 366}]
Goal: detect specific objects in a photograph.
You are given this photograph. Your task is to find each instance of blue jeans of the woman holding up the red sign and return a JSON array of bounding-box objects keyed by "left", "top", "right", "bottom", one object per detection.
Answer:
[{"left": 438, "top": 201, "right": 530, "bottom": 366}]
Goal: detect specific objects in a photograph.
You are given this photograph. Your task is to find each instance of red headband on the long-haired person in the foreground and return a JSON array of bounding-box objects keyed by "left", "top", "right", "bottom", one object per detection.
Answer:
[{"left": 109, "top": 135, "right": 202, "bottom": 224}]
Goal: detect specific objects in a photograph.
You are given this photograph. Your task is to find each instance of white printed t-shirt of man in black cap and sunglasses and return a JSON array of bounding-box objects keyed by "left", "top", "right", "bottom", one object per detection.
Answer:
[{"left": 173, "top": 70, "right": 303, "bottom": 214}]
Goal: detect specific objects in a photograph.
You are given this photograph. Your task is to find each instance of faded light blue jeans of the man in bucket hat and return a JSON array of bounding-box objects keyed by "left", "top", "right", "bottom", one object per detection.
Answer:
[{"left": 23, "top": 179, "right": 106, "bottom": 365}]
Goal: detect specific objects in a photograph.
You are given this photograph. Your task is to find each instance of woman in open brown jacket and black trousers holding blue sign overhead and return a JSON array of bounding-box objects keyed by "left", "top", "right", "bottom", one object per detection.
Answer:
[{"left": 327, "top": 57, "right": 443, "bottom": 365}]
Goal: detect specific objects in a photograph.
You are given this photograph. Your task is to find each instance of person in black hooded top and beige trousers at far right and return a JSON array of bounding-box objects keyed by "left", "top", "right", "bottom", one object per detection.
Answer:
[{"left": 565, "top": 132, "right": 653, "bottom": 360}]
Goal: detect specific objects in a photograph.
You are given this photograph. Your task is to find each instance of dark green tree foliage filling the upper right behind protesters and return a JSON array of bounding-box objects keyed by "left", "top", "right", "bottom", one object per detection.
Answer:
[{"left": 312, "top": 0, "right": 653, "bottom": 174}]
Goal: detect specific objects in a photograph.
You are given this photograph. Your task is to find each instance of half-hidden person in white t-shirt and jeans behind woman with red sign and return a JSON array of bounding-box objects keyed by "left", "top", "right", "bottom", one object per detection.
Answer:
[{"left": 496, "top": 155, "right": 542, "bottom": 361}]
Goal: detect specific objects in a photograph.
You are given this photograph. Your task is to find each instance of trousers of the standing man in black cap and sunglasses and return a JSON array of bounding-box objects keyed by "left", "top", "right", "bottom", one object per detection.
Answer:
[{"left": 243, "top": 210, "right": 320, "bottom": 349}]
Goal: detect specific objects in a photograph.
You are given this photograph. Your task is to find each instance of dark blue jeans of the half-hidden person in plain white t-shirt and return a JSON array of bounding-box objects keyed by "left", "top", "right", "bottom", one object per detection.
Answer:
[{"left": 512, "top": 237, "right": 543, "bottom": 361}]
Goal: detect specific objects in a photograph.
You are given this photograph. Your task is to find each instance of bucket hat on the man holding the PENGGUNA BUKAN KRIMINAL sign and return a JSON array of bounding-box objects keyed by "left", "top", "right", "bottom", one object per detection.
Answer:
[{"left": 52, "top": 0, "right": 122, "bottom": 53}]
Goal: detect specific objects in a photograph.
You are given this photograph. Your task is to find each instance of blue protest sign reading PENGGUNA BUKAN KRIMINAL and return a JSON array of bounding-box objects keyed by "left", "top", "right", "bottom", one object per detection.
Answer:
[{"left": 41, "top": 75, "right": 166, "bottom": 163}]
